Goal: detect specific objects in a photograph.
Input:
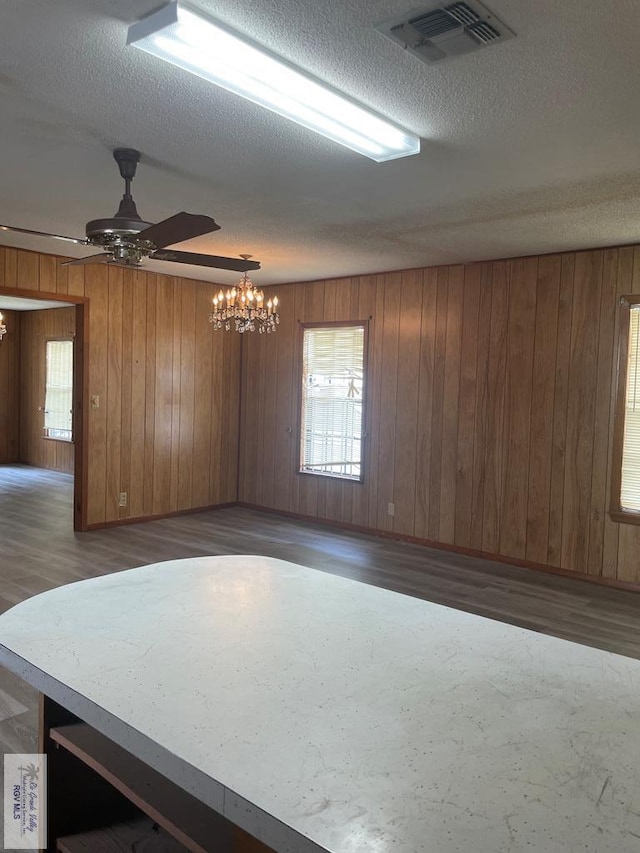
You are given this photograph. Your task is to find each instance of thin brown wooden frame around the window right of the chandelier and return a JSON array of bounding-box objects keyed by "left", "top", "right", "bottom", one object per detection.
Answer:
[{"left": 296, "top": 319, "right": 369, "bottom": 485}]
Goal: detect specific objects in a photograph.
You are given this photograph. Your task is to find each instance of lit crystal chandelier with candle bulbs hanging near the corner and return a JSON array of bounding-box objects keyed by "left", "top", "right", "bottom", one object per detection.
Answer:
[{"left": 209, "top": 255, "right": 280, "bottom": 334}]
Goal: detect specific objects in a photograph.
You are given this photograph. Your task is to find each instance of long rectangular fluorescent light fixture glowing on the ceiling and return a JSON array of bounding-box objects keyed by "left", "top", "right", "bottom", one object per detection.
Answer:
[{"left": 127, "top": 3, "right": 420, "bottom": 163}]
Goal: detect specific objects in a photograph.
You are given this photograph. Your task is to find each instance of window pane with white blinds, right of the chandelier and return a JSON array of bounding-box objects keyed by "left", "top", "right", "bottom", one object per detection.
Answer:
[{"left": 300, "top": 323, "right": 366, "bottom": 480}]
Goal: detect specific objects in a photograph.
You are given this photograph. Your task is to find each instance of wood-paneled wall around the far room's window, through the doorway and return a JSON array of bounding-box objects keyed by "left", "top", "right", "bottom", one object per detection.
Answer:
[{"left": 19, "top": 307, "right": 76, "bottom": 474}]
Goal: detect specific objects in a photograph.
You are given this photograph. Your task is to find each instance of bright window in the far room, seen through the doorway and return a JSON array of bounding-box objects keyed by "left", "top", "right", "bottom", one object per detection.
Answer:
[{"left": 44, "top": 340, "right": 73, "bottom": 441}]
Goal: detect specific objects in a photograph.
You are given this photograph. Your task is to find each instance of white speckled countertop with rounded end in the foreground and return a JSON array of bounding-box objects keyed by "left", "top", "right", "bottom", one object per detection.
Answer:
[{"left": 0, "top": 556, "right": 640, "bottom": 853}]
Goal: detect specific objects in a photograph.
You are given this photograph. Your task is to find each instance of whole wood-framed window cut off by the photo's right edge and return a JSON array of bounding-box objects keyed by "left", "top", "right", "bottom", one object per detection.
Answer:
[{"left": 613, "top": 296, "right": 640, "bottom": 522}]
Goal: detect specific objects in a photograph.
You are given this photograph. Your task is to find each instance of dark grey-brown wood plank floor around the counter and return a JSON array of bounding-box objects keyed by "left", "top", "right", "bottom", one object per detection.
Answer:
[{"left": 0, "top": 465, "right": 640, "bottom": 840}]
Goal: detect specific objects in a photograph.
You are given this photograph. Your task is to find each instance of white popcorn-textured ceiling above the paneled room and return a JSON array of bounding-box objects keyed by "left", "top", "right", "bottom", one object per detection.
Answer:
[{"left": 0, "top": 0, "right": 640, "bottom": 284}]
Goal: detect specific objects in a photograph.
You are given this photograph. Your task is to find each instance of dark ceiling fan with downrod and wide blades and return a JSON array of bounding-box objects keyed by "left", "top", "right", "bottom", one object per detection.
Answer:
[{"left": 0, "top": 148, "right": 260, "bottom": 272}]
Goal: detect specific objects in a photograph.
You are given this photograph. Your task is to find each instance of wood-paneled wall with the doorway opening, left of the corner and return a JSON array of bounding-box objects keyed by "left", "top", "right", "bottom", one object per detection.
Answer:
[{"left": 0, "top": 247, "right": 241, "bottom": 525}]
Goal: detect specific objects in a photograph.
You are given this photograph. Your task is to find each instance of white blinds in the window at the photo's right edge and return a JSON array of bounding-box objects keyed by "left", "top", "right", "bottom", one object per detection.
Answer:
[{"left": 620, "top": 305, "right": 640, "bottom": 512}]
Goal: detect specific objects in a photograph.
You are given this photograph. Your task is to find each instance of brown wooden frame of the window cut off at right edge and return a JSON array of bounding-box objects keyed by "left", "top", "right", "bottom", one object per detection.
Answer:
[{"left": 609, "top": 293, "right": 640, "bottom": 524}]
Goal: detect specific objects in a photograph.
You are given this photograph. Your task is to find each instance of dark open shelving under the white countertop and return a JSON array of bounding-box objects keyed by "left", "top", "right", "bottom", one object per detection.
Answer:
[{"left": 40, "top": 696, "right": 273, "bottom": 853}]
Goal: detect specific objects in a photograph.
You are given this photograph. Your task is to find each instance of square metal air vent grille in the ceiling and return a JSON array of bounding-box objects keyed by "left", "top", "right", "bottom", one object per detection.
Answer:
[{"left": 376, "top": 0, "right": 515, "bottom": 62}]
